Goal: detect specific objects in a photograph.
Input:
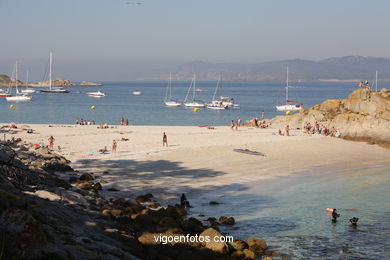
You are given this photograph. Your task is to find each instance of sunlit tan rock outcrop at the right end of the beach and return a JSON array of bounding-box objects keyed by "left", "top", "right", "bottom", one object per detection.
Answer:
[{"left": 271, "top": 89, "right": 390, "bottom": 148}]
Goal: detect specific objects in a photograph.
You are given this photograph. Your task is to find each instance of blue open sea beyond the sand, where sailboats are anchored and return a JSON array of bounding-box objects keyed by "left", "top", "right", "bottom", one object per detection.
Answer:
[{"left": 0, "top": 81, "right": 390, "bottom": 126}]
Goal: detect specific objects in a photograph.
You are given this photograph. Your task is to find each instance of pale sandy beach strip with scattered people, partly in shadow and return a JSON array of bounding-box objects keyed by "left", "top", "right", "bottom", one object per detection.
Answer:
[{"left": 8, "top": 125, "right": 390, "bottom": 199}]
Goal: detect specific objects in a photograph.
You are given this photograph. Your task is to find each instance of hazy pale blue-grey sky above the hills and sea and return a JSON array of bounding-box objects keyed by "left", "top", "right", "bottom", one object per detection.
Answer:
[{"left": 0, "top": 0, "right": 390, "bottom": 81}]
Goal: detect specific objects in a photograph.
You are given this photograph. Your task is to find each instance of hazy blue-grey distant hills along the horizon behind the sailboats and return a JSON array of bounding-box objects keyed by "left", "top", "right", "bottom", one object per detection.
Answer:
[{"left": 137, "top": 56, "right": 390, "bottom": 81}]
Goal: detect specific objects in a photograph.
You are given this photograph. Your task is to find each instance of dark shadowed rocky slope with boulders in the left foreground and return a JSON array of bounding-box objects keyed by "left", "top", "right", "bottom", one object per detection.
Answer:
[{"left": 0, "top": 139, "right": 276, "bottom": 260}]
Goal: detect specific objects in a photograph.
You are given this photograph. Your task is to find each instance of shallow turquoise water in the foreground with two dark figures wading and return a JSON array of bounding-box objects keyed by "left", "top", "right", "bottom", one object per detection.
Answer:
[{"left": 191, "top": 165, "right": 390, "bottom": 259}]
